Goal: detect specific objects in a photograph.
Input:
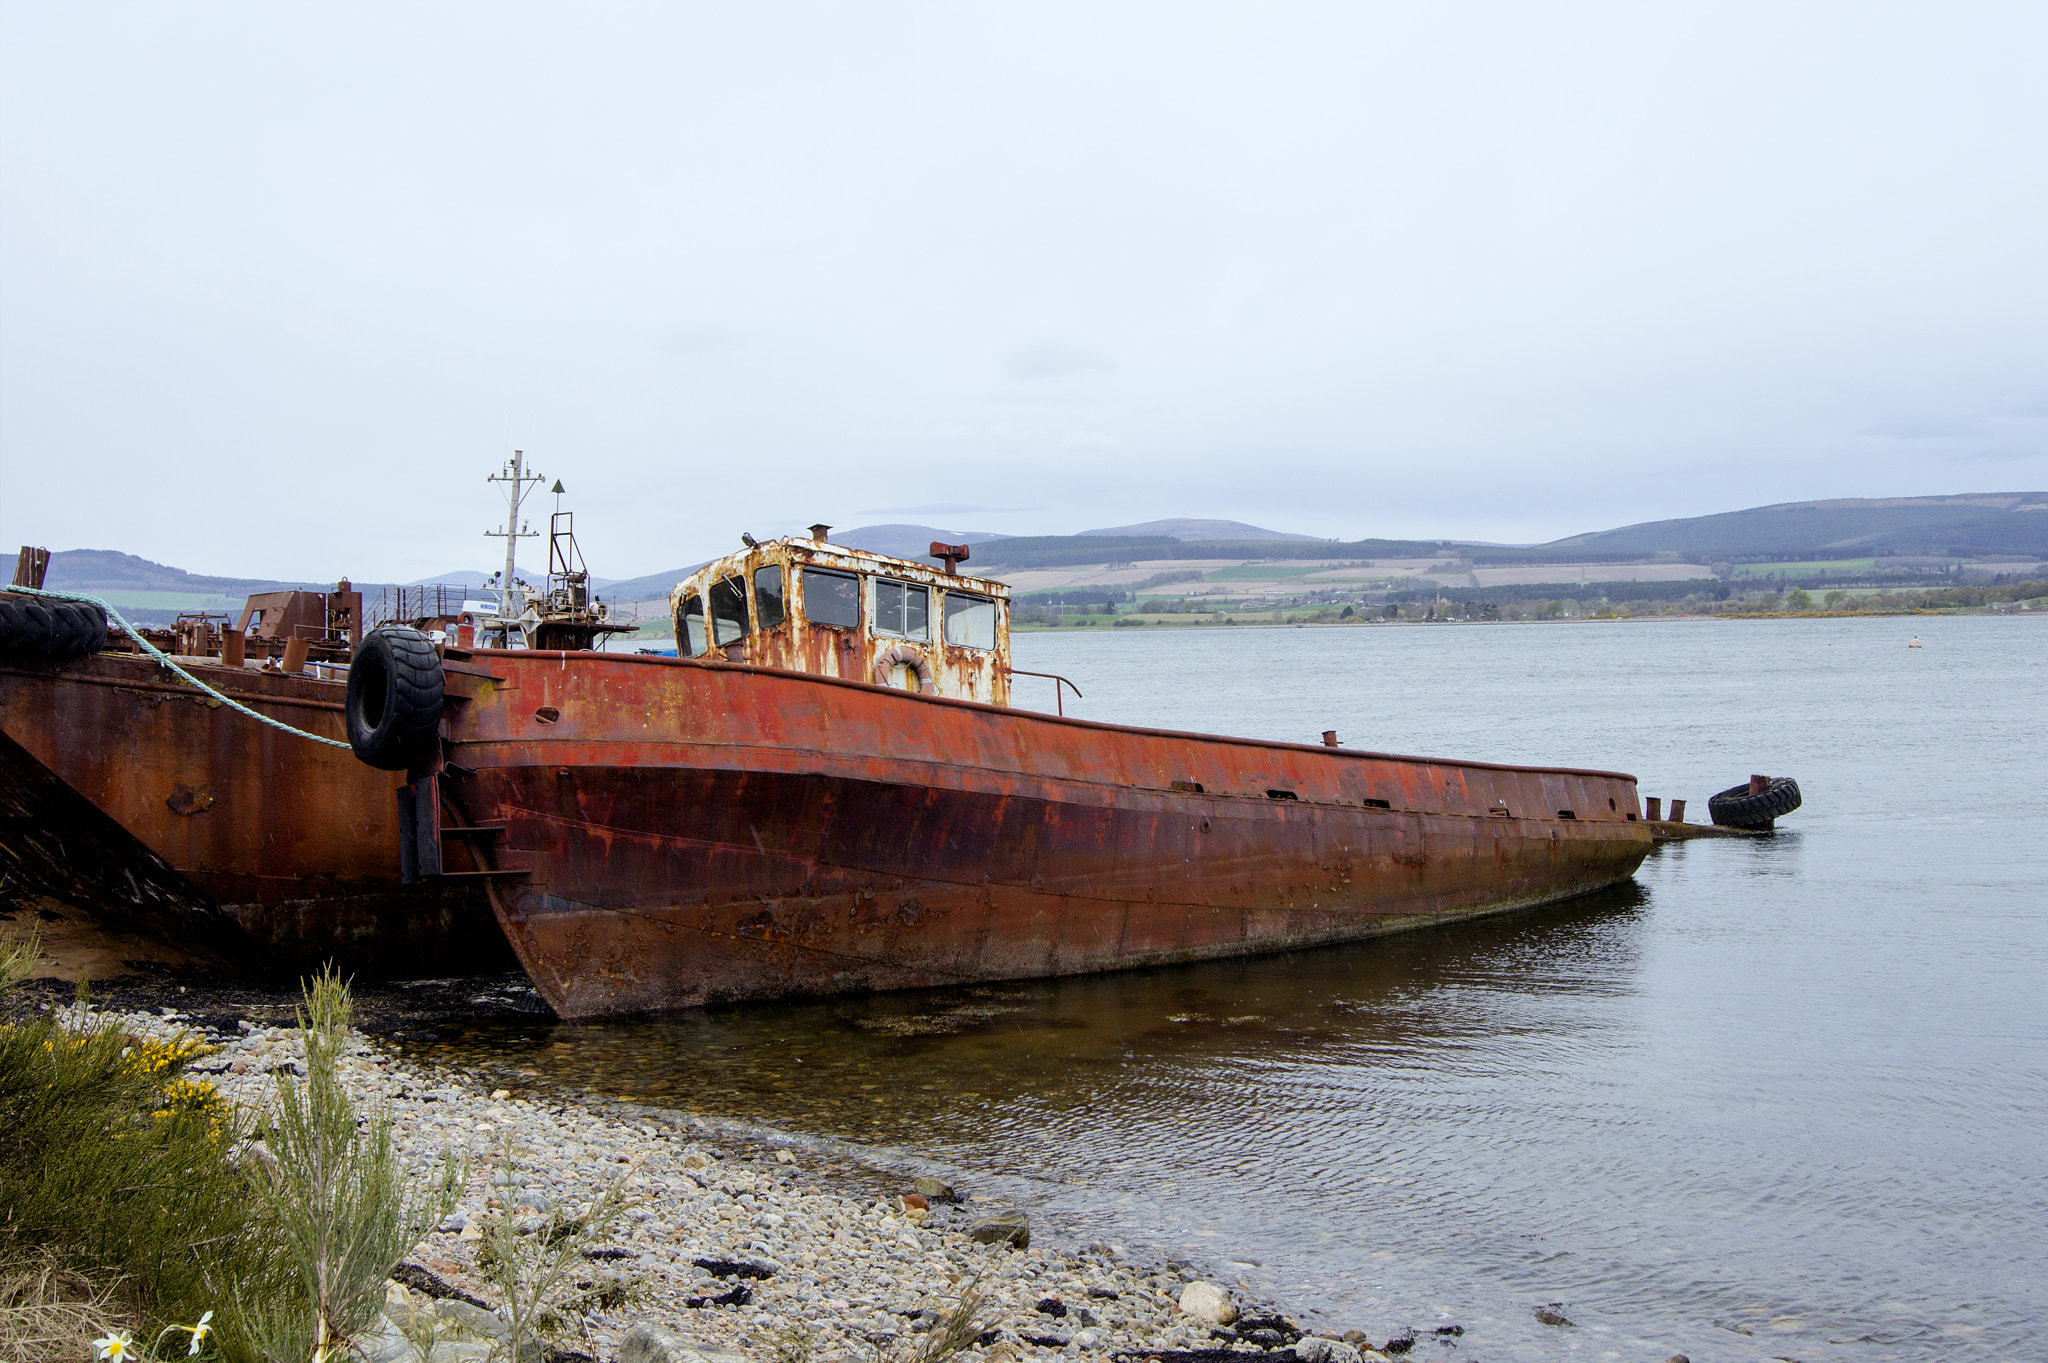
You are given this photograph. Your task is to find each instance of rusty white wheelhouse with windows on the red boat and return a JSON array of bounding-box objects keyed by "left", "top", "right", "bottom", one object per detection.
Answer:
[{"left": 668, "top": 526, "right": 1010, "bottom": 706}]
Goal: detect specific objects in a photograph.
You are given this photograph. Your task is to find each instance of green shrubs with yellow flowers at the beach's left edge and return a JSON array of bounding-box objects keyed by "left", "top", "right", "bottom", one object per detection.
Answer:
[{"left": 0, "top": 939, "right": 461, "bottom": 1363}]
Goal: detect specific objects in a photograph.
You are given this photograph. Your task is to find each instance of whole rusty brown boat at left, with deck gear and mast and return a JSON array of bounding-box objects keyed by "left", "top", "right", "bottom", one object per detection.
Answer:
[{"left": 0, "top": 454, "right": 633, "bottom": 978}]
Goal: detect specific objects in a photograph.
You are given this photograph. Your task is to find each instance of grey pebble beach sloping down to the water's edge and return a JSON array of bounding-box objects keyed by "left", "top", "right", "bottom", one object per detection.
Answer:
[{"left": 88, "top": 1009, "right": 1384, "bottom": 1363}]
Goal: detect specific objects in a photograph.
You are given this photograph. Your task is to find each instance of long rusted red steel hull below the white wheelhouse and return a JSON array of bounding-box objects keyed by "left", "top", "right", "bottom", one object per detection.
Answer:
[{"left": 442, "top": 653, "right": 1651, "bottom": 1017}]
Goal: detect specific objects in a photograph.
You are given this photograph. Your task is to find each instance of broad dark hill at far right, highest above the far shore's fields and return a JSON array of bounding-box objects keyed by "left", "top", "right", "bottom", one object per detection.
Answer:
[{"left": 1542, "top": 491, "right": 2048, "bottom": 561}]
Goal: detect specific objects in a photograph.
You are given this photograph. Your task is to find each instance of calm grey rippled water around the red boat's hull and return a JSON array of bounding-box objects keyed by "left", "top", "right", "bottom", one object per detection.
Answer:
[{"left": 407, "top": 618, "right": 2048, "bottom": 1361}]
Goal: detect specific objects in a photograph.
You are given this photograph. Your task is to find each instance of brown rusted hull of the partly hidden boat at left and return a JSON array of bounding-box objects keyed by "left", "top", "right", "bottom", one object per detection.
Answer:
[{"left": 0, "top": 653, "right": 510, "bottom": 978}]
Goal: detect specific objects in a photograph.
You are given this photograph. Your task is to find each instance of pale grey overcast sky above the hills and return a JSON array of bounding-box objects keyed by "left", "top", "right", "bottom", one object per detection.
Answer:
[{"left": 0, "top": 0, "right": 2048, "bottom": 579}]
